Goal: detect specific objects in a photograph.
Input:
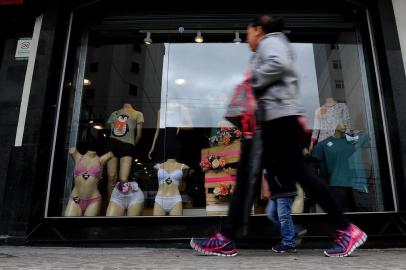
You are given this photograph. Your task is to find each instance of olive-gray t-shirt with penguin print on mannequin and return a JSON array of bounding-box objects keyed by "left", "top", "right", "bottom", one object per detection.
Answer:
[{"left": 107, "top": 110, "right": 144, "bottom": 144}]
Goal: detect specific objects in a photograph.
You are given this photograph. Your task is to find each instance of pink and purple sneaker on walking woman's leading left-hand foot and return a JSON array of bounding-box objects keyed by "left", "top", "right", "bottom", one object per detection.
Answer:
[{"left": 190, "top": 233, "right": 237, "bottom": 256}]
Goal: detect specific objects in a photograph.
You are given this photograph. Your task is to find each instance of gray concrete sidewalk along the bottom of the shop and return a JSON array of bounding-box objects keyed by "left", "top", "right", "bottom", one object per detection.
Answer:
[{"left": 0, "top": 246, "right": 406, "bottom": 270}]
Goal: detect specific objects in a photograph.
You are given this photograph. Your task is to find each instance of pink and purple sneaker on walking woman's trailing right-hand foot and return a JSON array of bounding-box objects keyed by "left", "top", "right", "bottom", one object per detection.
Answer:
[{"left": 324, "top": 224, "right": 367, "bottom": 257}]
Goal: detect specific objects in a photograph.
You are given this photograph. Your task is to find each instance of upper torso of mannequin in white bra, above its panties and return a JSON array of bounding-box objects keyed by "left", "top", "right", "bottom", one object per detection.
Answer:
[{"left": 154, "top": 159, "right": 189, "bottom": 197}]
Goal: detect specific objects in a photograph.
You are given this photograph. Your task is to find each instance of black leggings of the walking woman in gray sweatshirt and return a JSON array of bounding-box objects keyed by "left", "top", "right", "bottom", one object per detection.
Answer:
[{"left": 221, "top": 116, "right": 349, "bottom": 239}]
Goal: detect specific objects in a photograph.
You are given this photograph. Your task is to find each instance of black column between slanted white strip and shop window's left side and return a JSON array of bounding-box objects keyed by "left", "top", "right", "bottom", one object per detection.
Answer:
[{"left": 2, "top": 1, "right": 69, "bottom": 243}]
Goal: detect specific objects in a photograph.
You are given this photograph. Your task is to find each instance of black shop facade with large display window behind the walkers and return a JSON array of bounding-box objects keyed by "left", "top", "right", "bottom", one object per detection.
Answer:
[{"left": 0, "top": 0, "right": 406, "bottom": 245}]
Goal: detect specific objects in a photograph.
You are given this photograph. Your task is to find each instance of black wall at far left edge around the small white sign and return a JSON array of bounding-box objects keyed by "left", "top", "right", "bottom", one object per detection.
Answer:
[{"left": 0, "top": 0, "right": 41, "bottom": 235}]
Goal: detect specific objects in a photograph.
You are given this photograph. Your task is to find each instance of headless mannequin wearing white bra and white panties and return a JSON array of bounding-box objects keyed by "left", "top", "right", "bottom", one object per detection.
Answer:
[{"left": 153, "top": 159, "right": 189, "bottom": 216}]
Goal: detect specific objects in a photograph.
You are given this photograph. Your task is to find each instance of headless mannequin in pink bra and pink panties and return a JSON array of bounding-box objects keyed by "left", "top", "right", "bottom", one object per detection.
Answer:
[{"left": 64, "top": 148, "right": 113, "bottom": 217}]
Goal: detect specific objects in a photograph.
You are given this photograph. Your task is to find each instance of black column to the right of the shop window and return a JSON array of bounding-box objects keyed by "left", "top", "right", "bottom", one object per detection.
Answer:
[{"left": 371, "top": 0, "right": 406, "bottom": 211}]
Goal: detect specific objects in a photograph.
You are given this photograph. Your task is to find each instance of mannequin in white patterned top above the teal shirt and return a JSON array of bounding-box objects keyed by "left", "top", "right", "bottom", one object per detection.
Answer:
[{"left": 309, "top": 98, "right": 351, "bottom": 152}]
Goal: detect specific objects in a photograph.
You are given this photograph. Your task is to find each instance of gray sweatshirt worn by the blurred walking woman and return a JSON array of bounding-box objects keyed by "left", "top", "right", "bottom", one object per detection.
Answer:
[{"left": 251, "top": 32, "right": 304, "bottom": 121}]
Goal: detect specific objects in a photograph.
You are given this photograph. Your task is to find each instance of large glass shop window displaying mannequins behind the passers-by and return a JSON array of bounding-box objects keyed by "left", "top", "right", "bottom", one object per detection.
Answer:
[{"left": 47, "top": 14, "right": 390, "bottom": 217}]
